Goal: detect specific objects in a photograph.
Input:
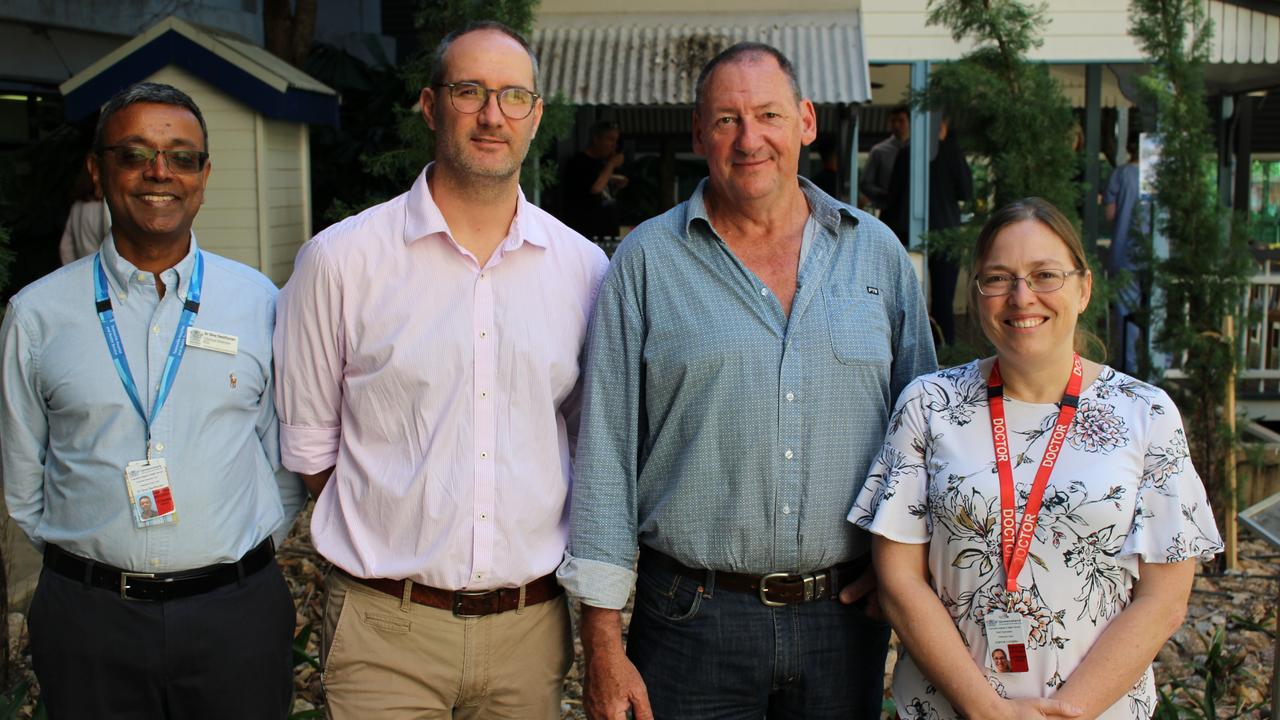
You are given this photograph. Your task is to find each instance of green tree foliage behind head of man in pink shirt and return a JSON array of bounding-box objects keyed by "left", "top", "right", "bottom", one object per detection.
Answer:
[{"left": 345, "top": 0, "right": 573, "bottom": 215}]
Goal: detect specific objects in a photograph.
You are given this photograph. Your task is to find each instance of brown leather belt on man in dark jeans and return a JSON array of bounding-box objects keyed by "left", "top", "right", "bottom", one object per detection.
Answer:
[{"left": 640, "top": 547, "right": 870, "bottom": 607}]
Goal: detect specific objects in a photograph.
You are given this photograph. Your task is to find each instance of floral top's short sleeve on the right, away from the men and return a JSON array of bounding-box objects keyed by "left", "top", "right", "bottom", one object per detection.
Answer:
[{"left": 1120, "top": 396, "right": 1222, "bottom": 562}]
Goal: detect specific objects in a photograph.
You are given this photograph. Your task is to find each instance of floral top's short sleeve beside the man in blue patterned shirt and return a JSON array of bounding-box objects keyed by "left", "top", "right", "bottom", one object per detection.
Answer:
[{"left": 849, "top": 379, "right": 933, "bottom": 544}]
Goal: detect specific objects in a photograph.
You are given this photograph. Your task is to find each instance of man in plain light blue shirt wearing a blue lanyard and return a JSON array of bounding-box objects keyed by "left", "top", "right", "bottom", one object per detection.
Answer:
[{"left": 0, "top": 83, "right": 305, "bottom": 719}]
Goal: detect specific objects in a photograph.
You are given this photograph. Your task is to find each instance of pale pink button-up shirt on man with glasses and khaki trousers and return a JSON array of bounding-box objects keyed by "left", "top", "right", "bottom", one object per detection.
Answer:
[{"left": 274, "top": 168, "right": 608, "bottom": 589}]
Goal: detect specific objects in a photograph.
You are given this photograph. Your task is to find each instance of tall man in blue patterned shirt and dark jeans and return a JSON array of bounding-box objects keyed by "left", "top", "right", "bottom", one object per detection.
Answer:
[{"left": 559, "top": 44, "right": 936, "bottom": 719}]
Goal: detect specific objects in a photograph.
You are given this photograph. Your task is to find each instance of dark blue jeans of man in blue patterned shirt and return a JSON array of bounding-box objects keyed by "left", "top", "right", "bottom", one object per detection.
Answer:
[{"left": 627, "top": 550, "right": 890, "bottom": 720}]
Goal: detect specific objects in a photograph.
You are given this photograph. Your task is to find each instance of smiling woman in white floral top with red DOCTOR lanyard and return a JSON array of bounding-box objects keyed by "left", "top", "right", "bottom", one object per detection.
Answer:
[{"left": 849, "top": 199, "right": 1221, "bottom": 720}]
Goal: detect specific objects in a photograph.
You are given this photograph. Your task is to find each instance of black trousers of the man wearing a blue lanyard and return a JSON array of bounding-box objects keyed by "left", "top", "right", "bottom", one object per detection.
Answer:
[{"left": 27, "top": 560, "right": 294, "bottom": 720}]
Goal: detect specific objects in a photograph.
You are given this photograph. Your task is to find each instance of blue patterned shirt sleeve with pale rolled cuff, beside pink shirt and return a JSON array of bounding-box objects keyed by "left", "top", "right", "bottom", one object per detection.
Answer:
[{"left": 557, "top": 252, "right": 644, "bottom": 609}]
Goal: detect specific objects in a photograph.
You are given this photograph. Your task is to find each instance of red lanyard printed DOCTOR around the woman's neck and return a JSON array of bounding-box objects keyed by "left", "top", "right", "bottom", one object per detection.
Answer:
[{"left": 987, "top": 355, "right": 1084, "bottom": 592}]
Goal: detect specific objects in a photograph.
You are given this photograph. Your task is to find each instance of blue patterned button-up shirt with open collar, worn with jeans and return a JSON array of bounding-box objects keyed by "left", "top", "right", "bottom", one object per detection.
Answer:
[{"left": 559, "top": 178, "right": 937, "bottom": 609}]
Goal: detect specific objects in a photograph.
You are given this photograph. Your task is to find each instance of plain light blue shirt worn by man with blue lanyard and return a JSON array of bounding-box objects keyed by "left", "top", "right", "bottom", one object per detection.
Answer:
[{"left": 0, "top": 236, "right": 306, "bottom": 573}]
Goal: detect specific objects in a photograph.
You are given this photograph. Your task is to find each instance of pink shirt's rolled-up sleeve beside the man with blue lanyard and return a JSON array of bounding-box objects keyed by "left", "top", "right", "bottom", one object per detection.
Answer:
[{"left": 274, "top": 240, "right": 346, "bottom": 474}]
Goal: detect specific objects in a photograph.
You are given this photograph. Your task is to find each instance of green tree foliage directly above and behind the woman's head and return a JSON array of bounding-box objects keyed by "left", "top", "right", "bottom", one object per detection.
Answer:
[{"left": 914, "top": 0, "right": 1080, "bottom": 217}]
